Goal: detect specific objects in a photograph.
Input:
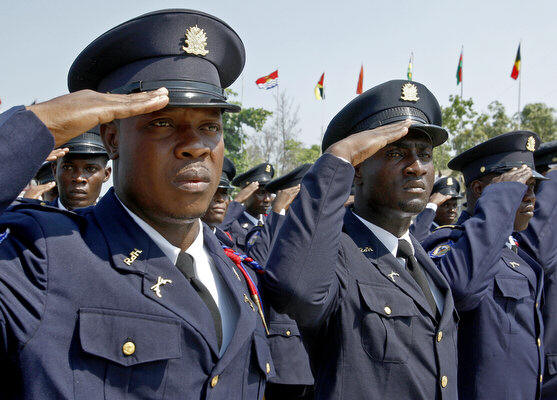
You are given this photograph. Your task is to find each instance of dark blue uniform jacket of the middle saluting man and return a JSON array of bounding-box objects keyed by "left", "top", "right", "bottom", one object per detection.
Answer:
[{"left": 262, "top": 154, "right": 457, "bottom": 400}]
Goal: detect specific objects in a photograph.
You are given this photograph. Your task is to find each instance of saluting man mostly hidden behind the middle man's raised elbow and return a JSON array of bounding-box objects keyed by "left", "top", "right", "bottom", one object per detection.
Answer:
[{"left": 246, "top": 164, "right": 314, "bottom": 400}]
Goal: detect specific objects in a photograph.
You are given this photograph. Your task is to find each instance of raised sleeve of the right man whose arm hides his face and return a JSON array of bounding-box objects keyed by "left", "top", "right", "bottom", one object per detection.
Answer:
[{"left": 430, "top": 182, "right": 527, "bottom": 311}]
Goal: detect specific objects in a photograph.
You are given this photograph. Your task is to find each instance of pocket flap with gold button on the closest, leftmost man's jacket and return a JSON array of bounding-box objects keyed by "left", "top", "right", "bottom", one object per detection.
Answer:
[{"left": 79, "top": 308, "right": 182, "bottom": 367}]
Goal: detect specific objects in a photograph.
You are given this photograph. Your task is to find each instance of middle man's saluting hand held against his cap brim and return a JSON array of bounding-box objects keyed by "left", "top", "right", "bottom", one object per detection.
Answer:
[{"left": 325, "top": 120, "right": 412, "bottom": 165}]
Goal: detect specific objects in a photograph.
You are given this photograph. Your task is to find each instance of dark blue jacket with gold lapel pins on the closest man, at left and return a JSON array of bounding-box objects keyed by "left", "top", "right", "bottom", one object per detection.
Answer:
[{"left": 0, "top": 109, "right": 274, "bottom": 400}]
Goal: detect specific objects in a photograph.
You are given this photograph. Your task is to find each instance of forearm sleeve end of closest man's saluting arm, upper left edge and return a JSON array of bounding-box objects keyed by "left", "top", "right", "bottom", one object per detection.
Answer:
[{"left": 0, "top": 106, "right": 54, "bottom": 212}]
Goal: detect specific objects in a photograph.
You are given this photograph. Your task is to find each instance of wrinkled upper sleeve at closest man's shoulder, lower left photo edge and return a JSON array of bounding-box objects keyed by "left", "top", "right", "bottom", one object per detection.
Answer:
[{"left": 0, "top": 211, "right": 47, "bottom": 356}]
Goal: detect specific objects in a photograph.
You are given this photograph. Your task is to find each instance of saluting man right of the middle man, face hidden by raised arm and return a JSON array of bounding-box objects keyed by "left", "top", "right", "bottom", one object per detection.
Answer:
[{"left": 423, "top": 131, "right": 543, "bottom": 399}]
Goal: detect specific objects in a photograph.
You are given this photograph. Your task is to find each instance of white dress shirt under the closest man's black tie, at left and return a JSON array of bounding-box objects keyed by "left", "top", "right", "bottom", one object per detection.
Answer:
[{"left": 116, "top": 197, "right": 240, "bottom": 356}]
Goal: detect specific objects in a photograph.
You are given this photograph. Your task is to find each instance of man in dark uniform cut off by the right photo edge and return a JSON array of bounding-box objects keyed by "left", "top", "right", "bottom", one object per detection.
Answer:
[{"left": 516, "top": 141, "right": 557, "bottom": 400}]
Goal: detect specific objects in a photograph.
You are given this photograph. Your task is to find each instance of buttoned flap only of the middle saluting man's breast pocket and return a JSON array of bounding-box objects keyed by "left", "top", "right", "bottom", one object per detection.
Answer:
[{"left": 358, "top": 282, "right": 418, "bottom": 318}]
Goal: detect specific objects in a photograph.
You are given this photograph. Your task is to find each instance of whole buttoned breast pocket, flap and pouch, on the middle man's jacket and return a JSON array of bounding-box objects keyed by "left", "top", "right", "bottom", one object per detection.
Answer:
[{"left": 358, "top": 283, "right": 418, "bottom": 363}]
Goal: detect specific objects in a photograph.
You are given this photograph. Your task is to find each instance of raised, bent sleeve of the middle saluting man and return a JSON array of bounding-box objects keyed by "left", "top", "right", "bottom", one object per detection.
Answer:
[{"left": 262, "top": 154, "right": 354, "bottom": 329}]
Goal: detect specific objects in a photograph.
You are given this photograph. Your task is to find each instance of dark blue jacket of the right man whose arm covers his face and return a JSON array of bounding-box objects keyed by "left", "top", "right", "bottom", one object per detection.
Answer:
[{"left": 422, "top": 182, "right": 543, "bottom": 400}]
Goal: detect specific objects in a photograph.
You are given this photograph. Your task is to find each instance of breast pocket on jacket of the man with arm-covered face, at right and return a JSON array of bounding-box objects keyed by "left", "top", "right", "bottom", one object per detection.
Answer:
[{"left": 494, "top": 275, "right": 532, "bottom": 333}]
